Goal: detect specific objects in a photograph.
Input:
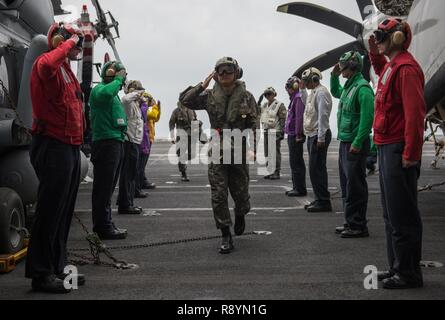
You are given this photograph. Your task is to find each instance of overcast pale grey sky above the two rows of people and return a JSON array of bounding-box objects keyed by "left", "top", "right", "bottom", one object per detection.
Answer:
[{"left": 58, "top": 0, "right": 361, "bottom": 137}]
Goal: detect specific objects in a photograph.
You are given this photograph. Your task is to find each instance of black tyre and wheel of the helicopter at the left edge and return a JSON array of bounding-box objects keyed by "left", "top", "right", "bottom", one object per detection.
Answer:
[{"left": 0, "top": 188, "right": 26, "bottom": 254}]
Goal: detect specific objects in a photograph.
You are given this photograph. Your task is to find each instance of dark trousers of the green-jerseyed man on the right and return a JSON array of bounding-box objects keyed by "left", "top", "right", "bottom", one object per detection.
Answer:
[{"left": 338, "top": 139, "right": 370, "bottom": 230}]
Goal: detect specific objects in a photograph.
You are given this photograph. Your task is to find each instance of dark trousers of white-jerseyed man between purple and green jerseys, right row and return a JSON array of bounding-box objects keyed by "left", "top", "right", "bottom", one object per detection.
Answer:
[{"left": 307, "top": 130, "right": 332, "bottom": 202}]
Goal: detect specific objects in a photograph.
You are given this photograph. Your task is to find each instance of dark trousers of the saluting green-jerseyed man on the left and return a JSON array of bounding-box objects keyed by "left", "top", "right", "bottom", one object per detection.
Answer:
[{"left": 91, "top": 140, "right": 124, "bottom": 232}]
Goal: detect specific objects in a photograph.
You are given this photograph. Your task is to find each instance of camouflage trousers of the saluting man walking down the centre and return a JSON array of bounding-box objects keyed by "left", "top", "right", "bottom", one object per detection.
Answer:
[{"left": 209, "top": 163, "right": 250, "bottom": 229}]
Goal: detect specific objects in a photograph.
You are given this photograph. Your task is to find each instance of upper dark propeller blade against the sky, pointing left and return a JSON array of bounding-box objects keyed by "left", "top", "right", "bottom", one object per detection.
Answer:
[{"left": 277, "top": 2, "right": 363, "bottom": 38}]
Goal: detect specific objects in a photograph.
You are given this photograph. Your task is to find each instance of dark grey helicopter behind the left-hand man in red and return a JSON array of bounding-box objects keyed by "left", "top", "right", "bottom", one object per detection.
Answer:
[{"left": 0, "top": 0, "right": 120, "bottom": 255}]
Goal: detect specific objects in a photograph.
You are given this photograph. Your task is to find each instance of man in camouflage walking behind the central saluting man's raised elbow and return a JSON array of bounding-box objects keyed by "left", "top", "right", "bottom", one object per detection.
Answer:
[{"left": 169, "top": 102, "right": 197, "bottom": 182}]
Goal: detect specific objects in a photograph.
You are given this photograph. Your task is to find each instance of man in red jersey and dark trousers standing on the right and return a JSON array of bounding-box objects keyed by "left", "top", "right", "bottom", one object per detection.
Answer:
[{"left": 369, "top": 18, "right": 426, "bottom": 289}]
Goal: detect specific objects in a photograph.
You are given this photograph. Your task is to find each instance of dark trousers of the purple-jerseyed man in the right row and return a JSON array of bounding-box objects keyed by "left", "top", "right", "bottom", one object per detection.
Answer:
[{"left": 287, "top": 136, "right": 307, "bottom": 194}]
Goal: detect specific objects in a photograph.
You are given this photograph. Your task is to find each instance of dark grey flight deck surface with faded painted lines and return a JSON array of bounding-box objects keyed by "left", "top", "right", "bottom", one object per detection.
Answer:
[{"left": 0, "top": 143, "right": 445, "bottom": 300}]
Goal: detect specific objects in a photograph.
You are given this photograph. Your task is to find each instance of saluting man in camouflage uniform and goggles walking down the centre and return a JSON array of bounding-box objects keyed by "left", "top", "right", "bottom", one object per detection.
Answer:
[{"left": 180, "top": 57, "right": 258, "bottom": 254}]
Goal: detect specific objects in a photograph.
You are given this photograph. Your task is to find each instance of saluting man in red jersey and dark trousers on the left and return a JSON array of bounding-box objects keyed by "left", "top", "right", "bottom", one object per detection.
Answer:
[{"left": 26, "top": 23, "right": 84, "bottom": 293}]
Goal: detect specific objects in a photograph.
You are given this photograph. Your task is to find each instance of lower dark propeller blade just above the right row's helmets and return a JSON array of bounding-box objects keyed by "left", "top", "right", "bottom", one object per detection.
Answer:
[{"left": 294, "top": 41, "right": 365, "bottom": 78}]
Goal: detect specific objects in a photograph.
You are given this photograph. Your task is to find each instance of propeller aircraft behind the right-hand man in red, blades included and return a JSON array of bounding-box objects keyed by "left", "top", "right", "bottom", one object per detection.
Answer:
[{"left": 277, "top": 0, "right": 445, "bottom": 169}]
